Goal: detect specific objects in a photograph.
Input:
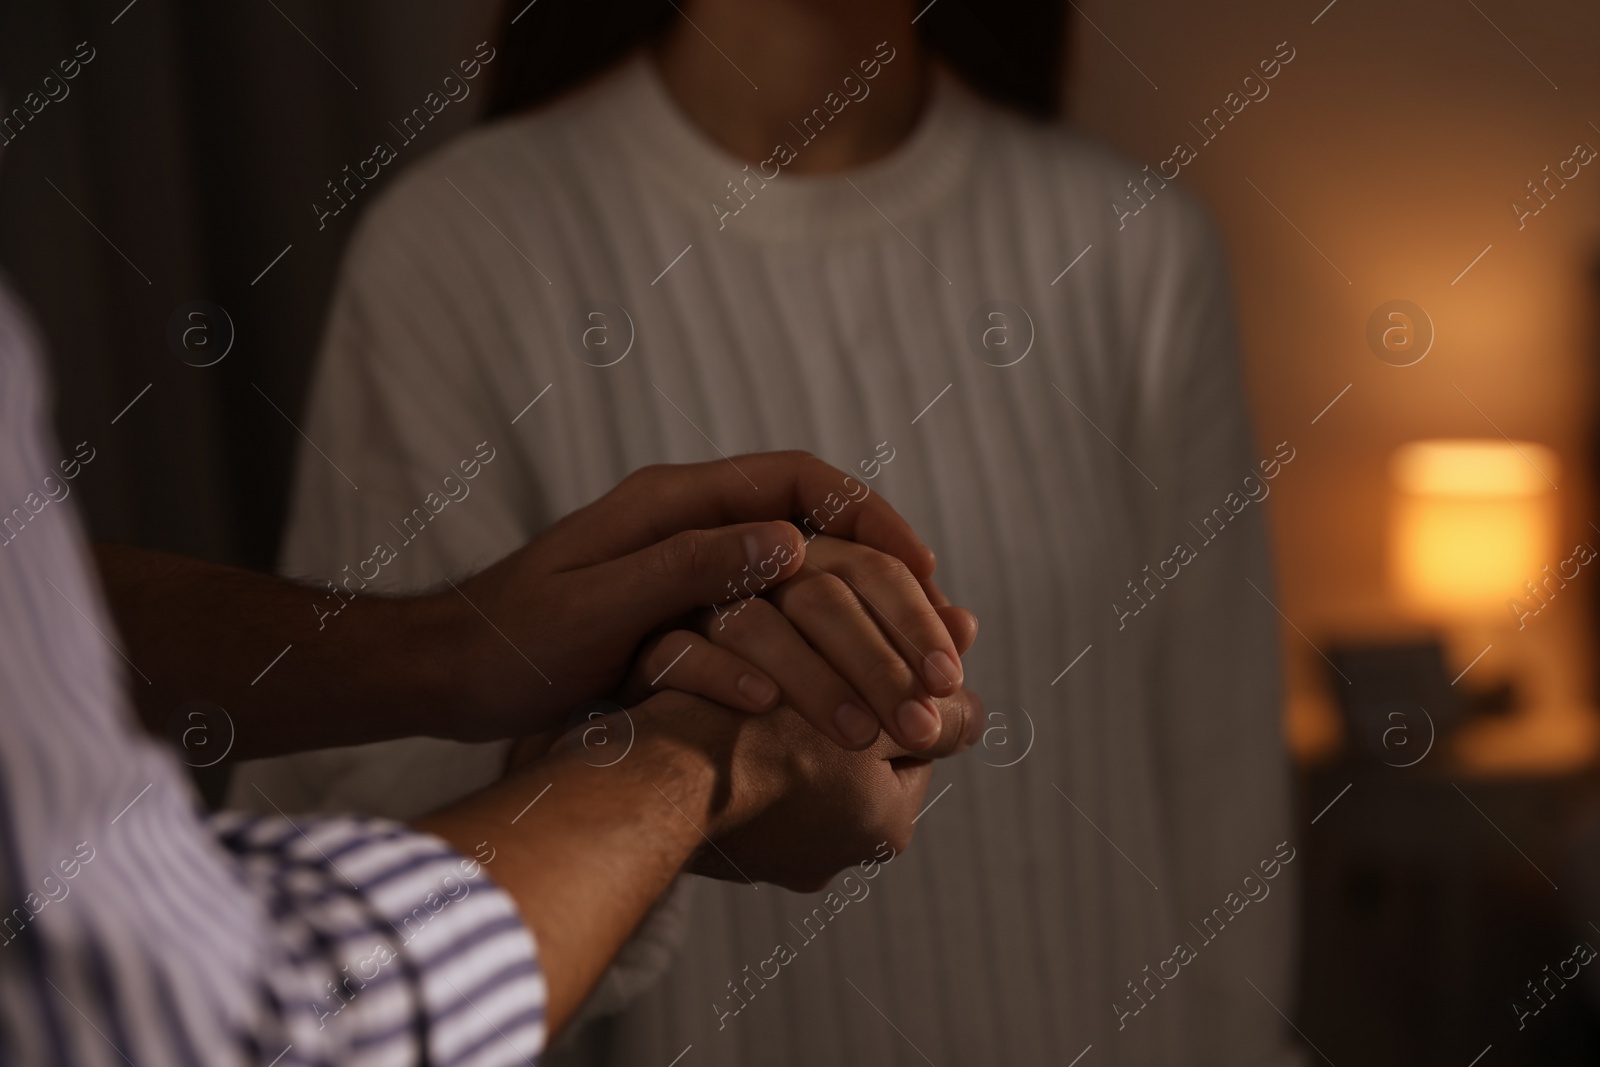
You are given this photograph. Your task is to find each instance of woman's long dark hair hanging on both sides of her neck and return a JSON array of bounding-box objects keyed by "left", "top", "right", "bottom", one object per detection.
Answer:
[{"left": 485, "top": 0, "right": 1066, "bottom": 118}]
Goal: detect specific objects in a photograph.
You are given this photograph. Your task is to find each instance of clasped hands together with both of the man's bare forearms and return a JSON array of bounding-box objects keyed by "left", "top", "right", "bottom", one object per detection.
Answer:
[{"left": 87, "top": 453, "right": 982, "bottom": 1032}]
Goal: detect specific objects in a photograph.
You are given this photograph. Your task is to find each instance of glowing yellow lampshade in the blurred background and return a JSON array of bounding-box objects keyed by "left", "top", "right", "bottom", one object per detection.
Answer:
[{"left": 1389, "top": 440, "right": 1557, "bottom": 622}]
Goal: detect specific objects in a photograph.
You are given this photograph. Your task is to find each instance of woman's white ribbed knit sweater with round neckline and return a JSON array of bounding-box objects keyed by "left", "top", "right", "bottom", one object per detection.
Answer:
[{"left": 235, "top": 51, "right": 1294, "bottom": 1067}]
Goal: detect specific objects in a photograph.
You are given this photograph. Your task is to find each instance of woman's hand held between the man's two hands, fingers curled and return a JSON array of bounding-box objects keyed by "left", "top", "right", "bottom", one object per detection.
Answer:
[{"left": 621, "top": 536, "right": 978, "bottom": 752}]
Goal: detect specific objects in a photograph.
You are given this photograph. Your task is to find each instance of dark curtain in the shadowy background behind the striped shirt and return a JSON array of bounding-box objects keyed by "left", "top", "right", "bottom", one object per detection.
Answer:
[{"left": 0, "top": 0, "right": 496, "bottom": 568}]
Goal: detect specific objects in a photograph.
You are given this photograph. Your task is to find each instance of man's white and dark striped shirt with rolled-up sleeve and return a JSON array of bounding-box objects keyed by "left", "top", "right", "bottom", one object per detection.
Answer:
[{"left": 0, "top": 285, "right": 546, "bottom": 1067}]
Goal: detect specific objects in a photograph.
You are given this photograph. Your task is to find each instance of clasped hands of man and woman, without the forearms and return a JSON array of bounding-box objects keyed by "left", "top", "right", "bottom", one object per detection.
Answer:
[{"left": 453, "top": 453, "right": 982, "bottom": 889}]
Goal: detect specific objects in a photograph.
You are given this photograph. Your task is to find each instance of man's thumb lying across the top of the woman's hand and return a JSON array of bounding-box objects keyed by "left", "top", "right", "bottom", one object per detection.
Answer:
[{"left": 589, "top": 522, "right": 805, "bottom": 633}]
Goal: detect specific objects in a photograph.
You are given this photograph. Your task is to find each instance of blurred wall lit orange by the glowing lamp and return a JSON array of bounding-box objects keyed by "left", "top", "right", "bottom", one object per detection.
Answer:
[{"left": 1069, "top": 0, "right": 1600, "bottom": 751}]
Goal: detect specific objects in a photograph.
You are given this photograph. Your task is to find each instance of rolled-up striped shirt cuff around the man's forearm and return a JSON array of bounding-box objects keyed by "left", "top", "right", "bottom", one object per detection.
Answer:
[{"left": 211, "top": 813, "right": 546, "bottom": 1067}]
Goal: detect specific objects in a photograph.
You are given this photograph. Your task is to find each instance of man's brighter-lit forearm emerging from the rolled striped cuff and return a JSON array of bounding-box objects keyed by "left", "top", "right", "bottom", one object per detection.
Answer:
[{"left": 416, "top": 712, "right": 733, "bottom": 1033}]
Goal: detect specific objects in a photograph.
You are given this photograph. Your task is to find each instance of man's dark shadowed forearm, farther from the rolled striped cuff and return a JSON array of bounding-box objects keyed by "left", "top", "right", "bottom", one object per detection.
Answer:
[{"left": 94, "top": 545, "right": 467, "bottom": 758}]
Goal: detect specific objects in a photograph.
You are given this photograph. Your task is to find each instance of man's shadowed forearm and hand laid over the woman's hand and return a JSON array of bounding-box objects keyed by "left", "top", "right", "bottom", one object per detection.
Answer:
[{"left": 96, "top": 453, "right": 938, "bottom": 758}]
